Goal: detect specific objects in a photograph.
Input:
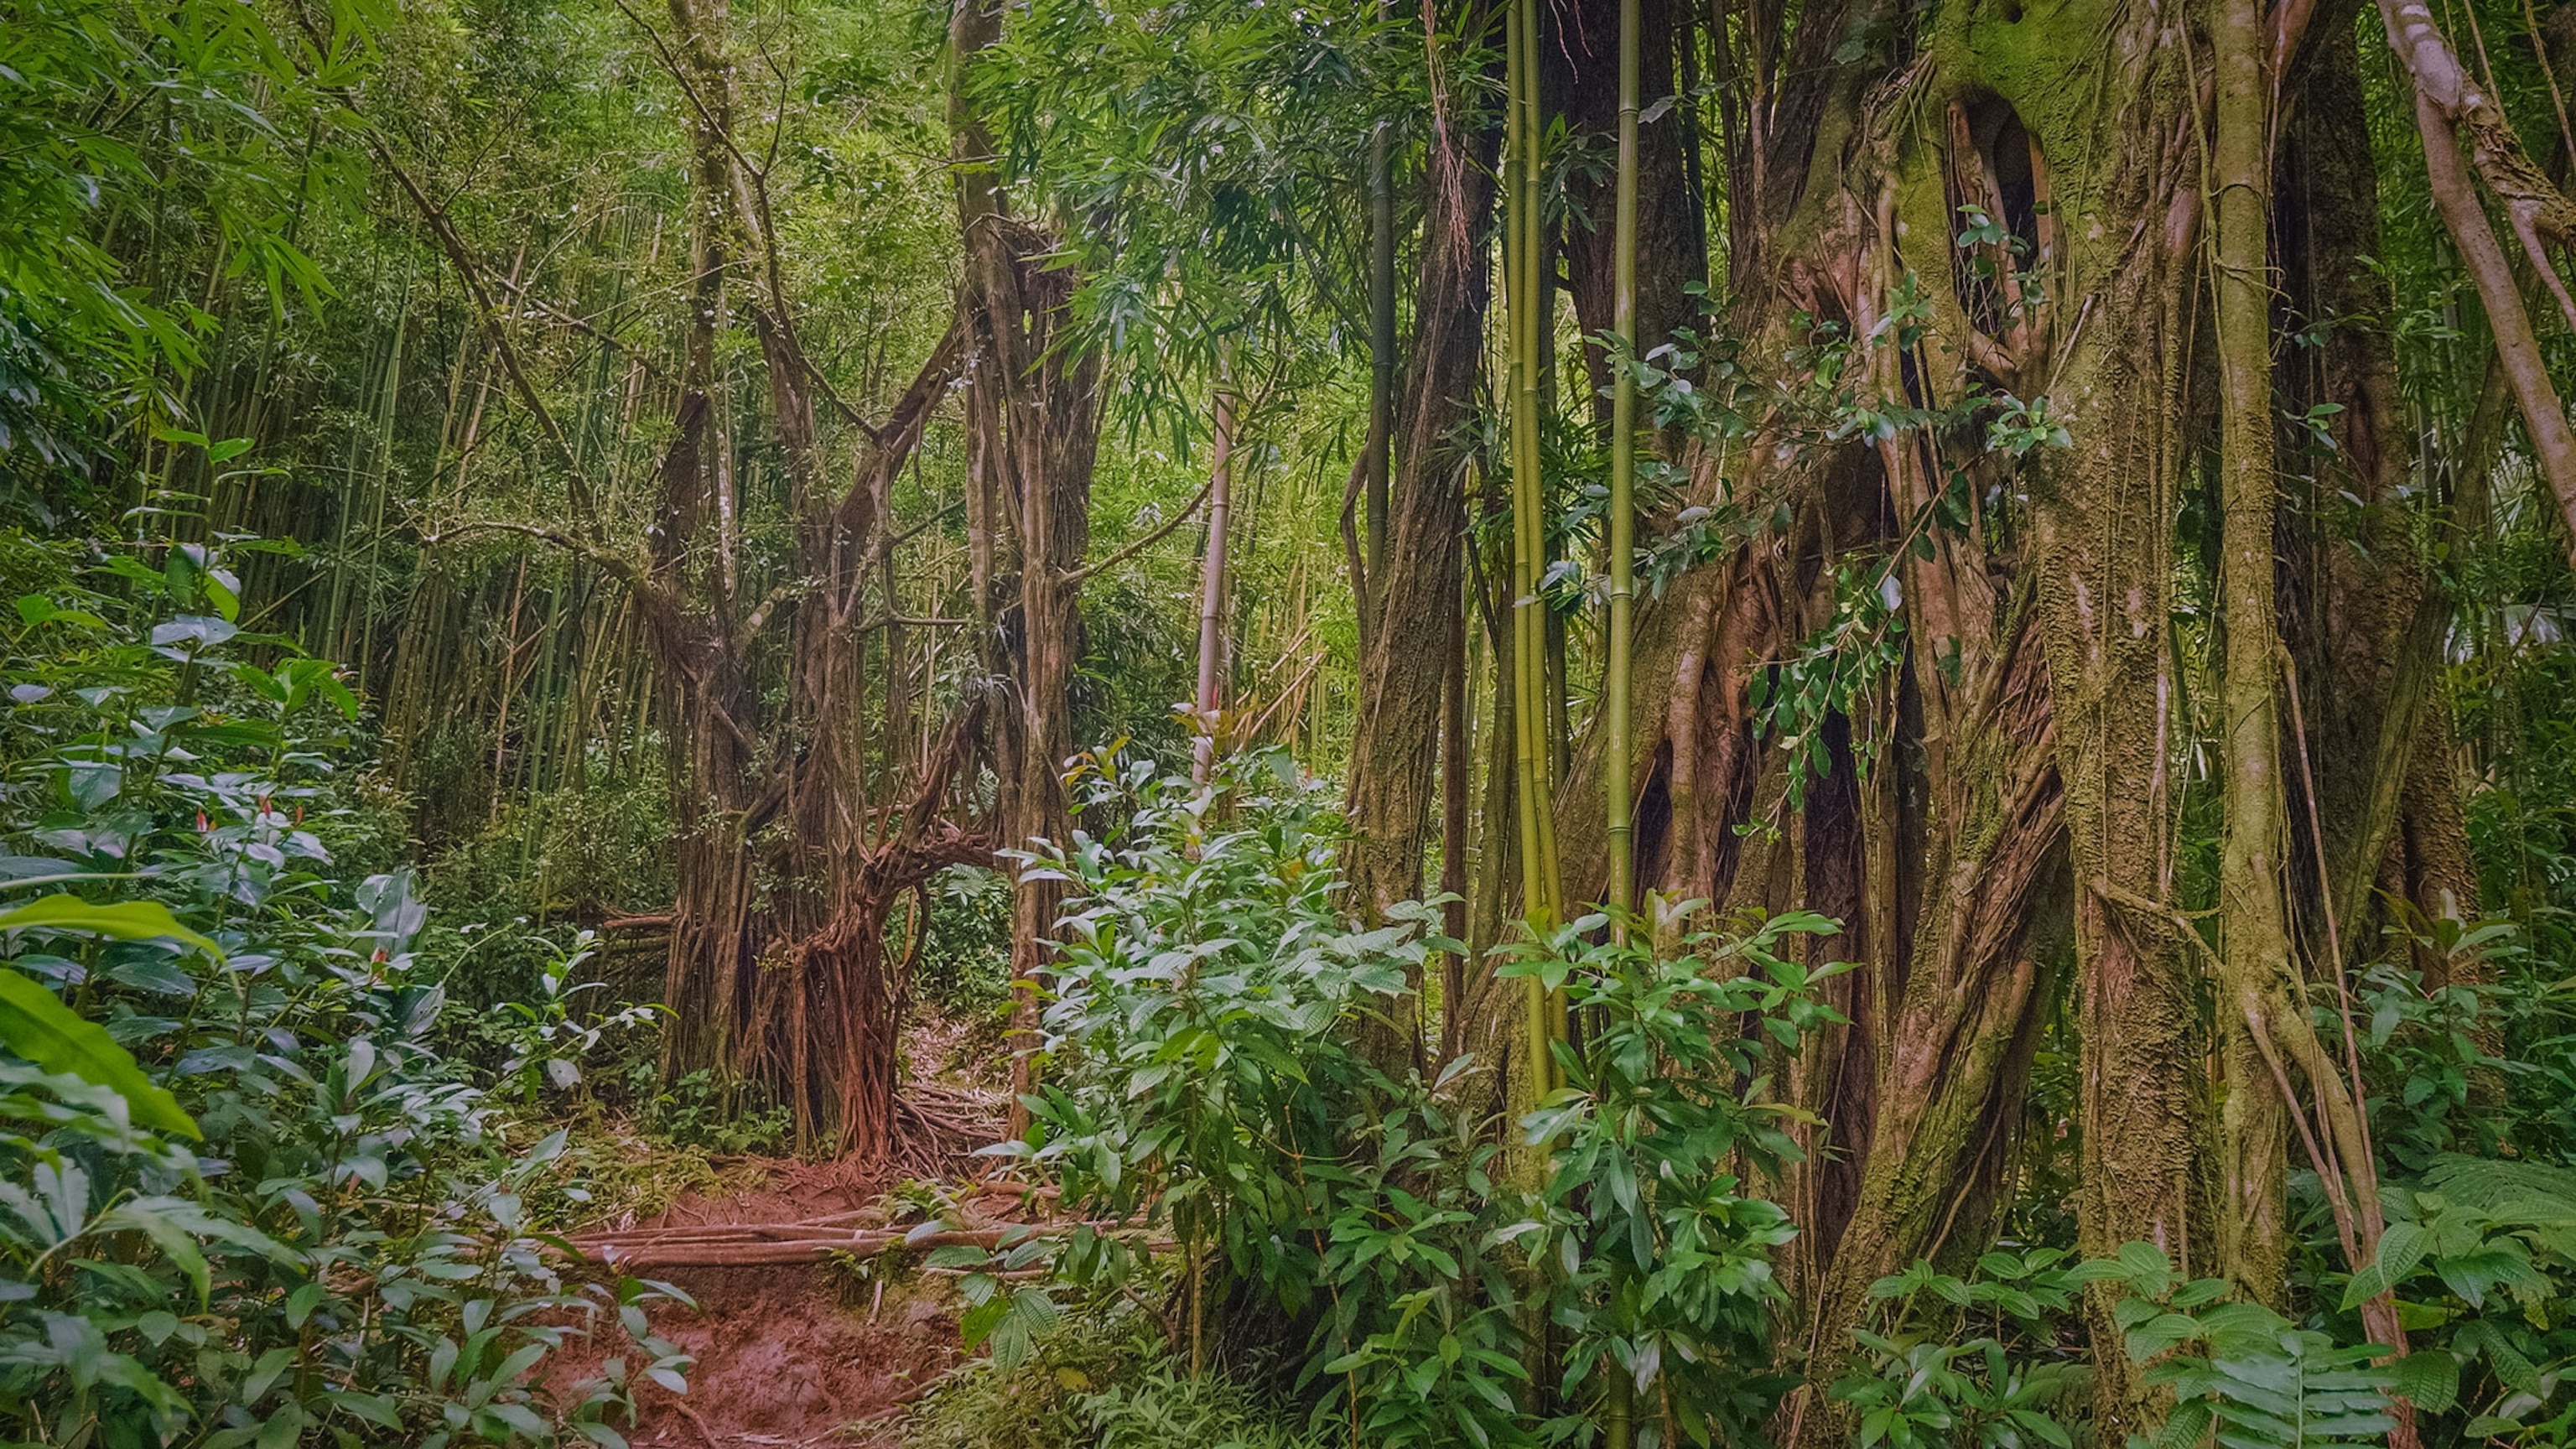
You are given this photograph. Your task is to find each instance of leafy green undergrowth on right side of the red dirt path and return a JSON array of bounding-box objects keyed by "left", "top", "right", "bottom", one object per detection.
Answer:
[{"left": 886, "top": 753, "right": 2576, "bottom": 1449}]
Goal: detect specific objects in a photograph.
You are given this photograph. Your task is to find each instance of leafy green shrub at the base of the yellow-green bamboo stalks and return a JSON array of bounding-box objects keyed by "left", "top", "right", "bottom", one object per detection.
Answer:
[{"left": 1497, "top": 902, "right": 1845, "bottom": 1449}]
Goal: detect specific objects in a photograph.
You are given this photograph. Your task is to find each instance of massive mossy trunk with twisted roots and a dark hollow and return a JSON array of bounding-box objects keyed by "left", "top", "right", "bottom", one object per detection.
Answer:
[{"left": 1564, "top": 3, "right": 2246, "bottom": 1441}]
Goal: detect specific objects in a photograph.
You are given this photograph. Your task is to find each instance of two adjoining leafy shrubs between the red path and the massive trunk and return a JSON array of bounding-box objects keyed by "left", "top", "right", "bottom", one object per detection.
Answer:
[{"left": 963, "top": 753, "right": 1831, "bottom": 1446}]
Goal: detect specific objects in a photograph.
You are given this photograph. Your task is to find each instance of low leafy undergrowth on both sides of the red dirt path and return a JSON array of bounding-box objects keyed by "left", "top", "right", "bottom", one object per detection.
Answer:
[{"left": 15, "top": 500, "right": 2576, "bottom": 1449}]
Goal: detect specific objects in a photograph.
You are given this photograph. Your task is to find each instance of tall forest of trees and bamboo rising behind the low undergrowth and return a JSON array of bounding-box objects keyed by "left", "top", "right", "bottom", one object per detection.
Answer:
[{"left": 0, "top": 0, "right": 2576, "bottom": 1449}]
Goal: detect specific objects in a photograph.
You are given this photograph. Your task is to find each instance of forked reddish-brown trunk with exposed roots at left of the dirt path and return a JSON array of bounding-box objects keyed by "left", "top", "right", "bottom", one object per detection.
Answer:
[{"left": 634, "top": 0, "right": 992, "bottom": 1158}]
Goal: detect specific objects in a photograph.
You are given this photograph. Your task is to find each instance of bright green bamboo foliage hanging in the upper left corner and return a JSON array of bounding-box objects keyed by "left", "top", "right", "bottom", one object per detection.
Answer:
[{"left": 0, "top": 0, "right": 368, "bottom": 470}]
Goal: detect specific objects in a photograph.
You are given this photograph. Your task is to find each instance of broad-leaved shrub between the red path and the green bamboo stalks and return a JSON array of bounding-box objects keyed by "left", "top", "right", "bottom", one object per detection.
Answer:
[{"left": 984, "top": 737, "right": 1430, "bottom": 1382}]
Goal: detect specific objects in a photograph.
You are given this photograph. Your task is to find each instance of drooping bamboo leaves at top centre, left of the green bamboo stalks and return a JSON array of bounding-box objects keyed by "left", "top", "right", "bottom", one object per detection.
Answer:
[{"left": 974, "top": 0, "right": 1411, "bottom": 418}]
